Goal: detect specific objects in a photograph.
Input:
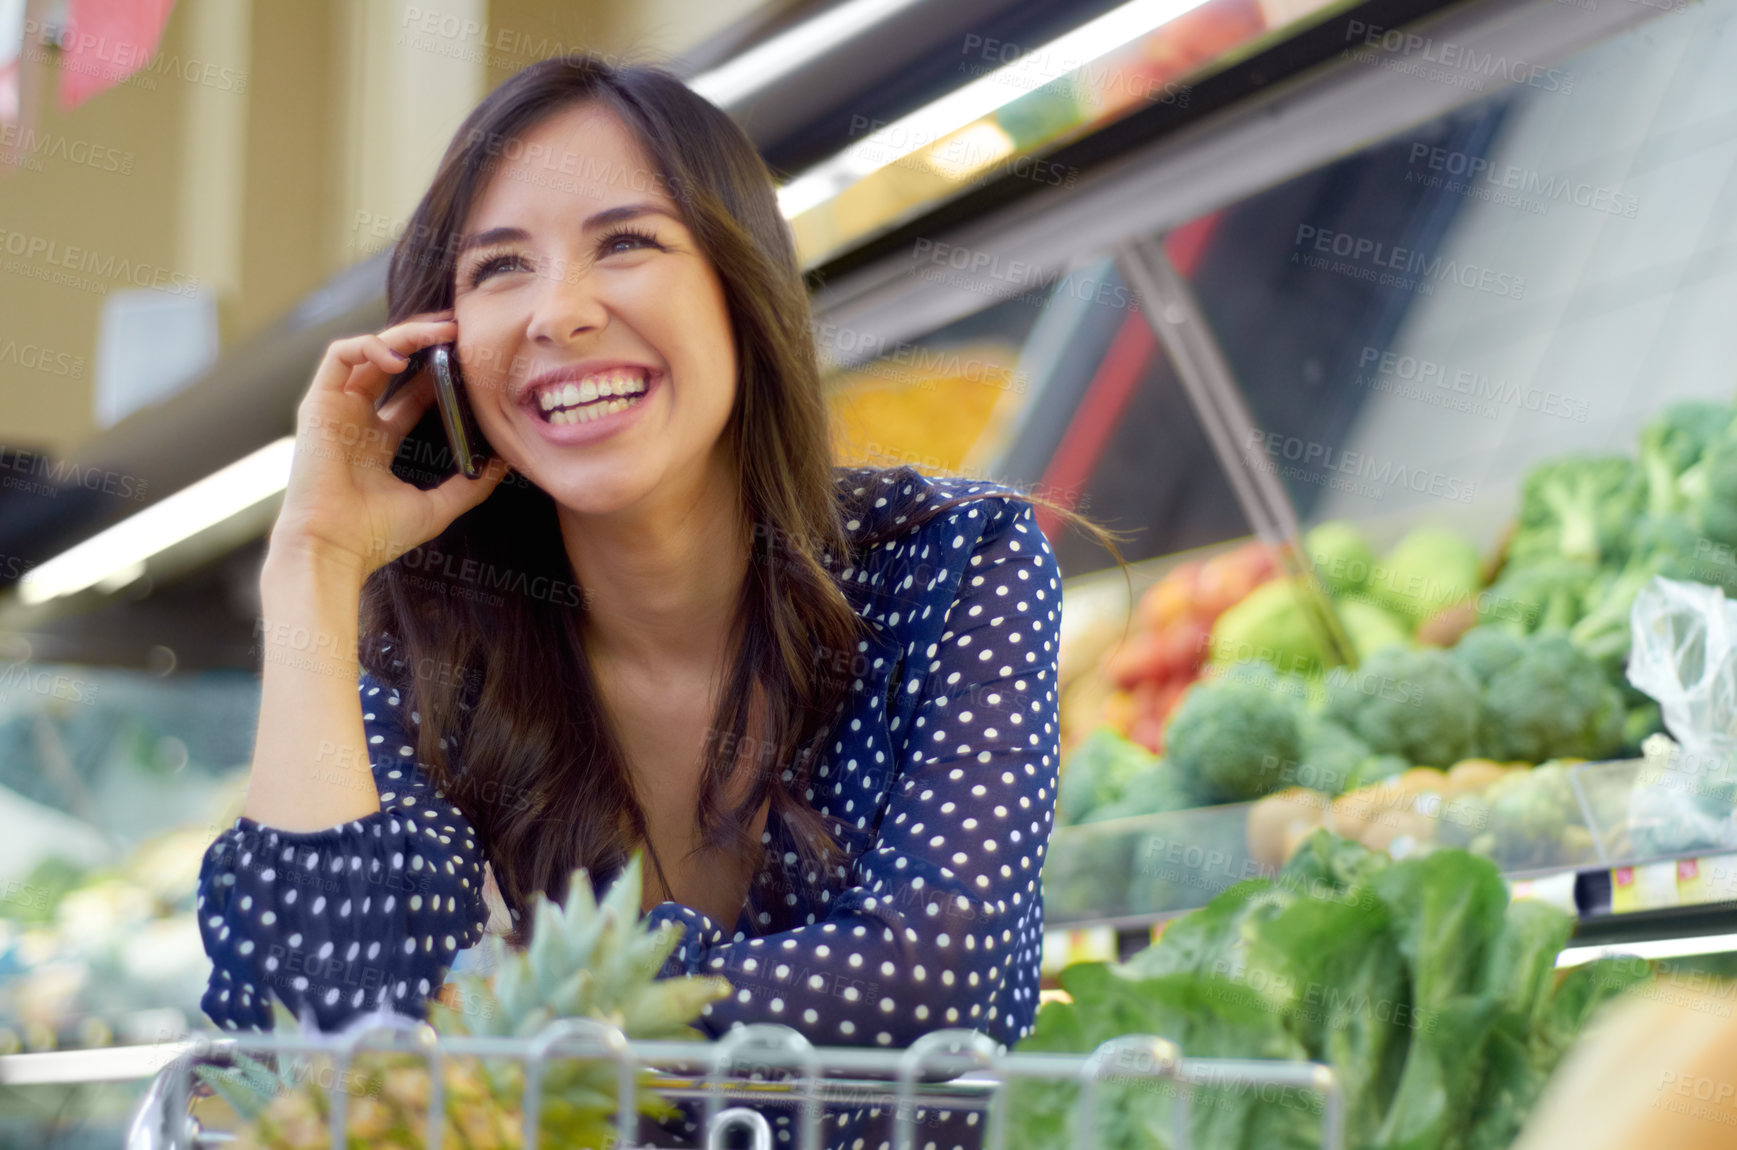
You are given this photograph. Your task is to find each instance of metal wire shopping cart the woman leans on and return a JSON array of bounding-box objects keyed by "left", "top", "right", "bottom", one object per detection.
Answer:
[{"left": 115, "top": 1018, "right": 1344, "bottom": 1150}]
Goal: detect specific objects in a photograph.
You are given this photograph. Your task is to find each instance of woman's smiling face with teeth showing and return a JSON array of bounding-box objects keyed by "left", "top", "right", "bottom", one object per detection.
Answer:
[{"left": 453, "top": 102, "right": 736, "bottom": 514}]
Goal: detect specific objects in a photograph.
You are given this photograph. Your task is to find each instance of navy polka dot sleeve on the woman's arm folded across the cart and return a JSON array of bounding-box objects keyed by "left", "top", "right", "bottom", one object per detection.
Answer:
[{"left": 650, "top": 497, "right": 1061, "bottom": 1046}]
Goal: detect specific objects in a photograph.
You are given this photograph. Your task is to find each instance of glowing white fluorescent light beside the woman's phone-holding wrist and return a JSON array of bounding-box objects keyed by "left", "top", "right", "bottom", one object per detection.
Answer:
[{"left": 17, "top": 436, "right": 295, "bottom": 605}]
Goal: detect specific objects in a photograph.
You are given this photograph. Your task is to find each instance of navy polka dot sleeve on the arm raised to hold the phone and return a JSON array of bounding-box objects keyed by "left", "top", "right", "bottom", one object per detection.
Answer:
[{"left": 196, "top": 672, "right": 488, "bottom": 1030}]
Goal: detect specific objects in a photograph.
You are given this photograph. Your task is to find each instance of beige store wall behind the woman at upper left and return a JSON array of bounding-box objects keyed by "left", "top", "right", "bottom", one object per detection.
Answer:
[{"left": 0, "top": 0, "right": 757, "bottom": 452}]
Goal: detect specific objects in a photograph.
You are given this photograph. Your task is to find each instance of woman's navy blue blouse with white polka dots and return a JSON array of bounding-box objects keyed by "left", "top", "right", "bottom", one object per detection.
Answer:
[{"left": 198, "top": 469, "right": 1061, "bottom": 1046}]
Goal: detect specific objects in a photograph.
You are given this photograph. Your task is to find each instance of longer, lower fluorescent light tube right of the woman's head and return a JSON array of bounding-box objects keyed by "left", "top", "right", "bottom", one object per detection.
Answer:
[{"left": 778, "top": 0, "right": 1205, "bottom": 217}]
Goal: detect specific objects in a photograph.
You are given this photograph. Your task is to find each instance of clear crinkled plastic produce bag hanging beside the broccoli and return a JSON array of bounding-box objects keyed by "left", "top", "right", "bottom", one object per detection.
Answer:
[{"left": 1628, "top": 577, "right": 1737, "bottom": 856}]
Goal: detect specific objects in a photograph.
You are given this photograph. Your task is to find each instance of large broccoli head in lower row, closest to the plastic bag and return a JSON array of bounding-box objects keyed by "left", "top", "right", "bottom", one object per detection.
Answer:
[{"left": 1483, "top": 636, "right": 1628, "bottom": 763}]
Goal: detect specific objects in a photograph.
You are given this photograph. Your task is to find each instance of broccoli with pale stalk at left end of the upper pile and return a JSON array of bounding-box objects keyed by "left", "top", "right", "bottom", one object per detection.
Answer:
[{"left": 1508, "top": 455, "right": 1647, "bottom": 565}]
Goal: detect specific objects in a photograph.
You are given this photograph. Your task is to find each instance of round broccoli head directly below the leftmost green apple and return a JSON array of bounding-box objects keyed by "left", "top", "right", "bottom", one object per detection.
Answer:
[{"left": 1164, "top": 664, "right": 1303, "bottom": 804}]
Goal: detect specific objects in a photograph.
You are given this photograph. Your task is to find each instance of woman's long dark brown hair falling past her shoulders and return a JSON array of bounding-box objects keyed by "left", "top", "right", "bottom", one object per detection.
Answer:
[{"left": 361, "top": 54, "right": 1113, "bottom": 945}]
